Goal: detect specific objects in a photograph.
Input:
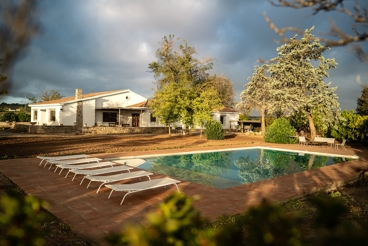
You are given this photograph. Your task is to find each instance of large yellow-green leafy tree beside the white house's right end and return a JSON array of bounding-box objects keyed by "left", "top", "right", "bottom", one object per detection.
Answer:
[{"left": 148, "top": 35, "right": 221, "bottom": 135}]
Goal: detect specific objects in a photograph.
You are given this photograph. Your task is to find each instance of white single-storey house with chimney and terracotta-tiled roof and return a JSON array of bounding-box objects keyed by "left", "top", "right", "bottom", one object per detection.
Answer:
[{"left": 29, "top": 89, "right": 238, "bottom": 129}]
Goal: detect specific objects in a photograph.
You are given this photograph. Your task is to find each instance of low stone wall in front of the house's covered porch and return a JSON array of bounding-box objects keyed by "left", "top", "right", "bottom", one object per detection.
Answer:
[{"left": 83, "top": 126, "right": 169, "bottom": 134}]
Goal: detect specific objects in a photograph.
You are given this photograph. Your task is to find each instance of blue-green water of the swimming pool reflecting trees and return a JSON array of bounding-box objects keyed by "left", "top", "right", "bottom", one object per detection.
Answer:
[{"left": 137, "top": 149, "right": 349, "bottom": 189}]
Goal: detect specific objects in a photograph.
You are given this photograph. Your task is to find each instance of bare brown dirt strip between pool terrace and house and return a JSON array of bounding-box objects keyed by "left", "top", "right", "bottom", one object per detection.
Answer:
[{"left": 0, "top": 134, "right": 264, "bottom": 159}]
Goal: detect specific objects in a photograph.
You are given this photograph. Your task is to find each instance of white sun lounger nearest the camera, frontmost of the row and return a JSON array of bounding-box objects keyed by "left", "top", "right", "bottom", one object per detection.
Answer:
[{"left": 106, "top": 178, "right": 180, "bottom": 205}]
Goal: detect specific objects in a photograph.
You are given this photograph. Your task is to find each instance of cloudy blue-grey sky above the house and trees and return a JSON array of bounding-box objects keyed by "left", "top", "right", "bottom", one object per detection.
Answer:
[{"left": 0, "top": 0, "right": 368, "bottom": 110}]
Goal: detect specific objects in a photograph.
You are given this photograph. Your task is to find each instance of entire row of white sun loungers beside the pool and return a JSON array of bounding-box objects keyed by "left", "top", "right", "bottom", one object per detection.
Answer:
[{"left": 37, "top": 155, "right": 180, "bottom": 205}]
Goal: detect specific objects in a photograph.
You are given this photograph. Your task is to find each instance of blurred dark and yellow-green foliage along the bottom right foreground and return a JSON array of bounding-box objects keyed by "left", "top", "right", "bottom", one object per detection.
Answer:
[{"left": 106, "top": 188, "right": 368, "bottom": 246}]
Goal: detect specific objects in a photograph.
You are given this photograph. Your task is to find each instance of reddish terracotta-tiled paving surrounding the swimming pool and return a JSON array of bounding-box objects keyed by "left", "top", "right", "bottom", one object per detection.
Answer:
[{"left": 0, "top": 143, "right": 368, "bottom": 242}]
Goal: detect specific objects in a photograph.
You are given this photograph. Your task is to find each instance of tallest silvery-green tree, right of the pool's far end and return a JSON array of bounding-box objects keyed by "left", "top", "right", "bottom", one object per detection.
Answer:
[{"left": 268, "top": 28, "right": 341, "bottom": 138}]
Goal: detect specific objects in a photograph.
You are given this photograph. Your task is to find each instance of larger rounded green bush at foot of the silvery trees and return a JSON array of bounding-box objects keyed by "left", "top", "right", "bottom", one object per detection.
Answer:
[{"left": 264, "top": 118, "right": 297, "bottom": 144}]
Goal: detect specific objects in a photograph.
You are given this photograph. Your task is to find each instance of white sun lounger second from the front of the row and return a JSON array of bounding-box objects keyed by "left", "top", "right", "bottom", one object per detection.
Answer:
[{"left": 81, "top": 171, "right": 153, "bottom": 193}]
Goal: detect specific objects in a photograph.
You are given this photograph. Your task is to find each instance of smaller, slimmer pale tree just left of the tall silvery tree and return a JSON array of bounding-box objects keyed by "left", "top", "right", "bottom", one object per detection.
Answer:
[{"left": 237, "top": 64, "right": 272, "bottom": 134}]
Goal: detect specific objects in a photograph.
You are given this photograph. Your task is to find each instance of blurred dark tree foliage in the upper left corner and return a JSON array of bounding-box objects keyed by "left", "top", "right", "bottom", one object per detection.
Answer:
[{"left": 0, "top": 0, "right": 40, "bottom": 93}]
